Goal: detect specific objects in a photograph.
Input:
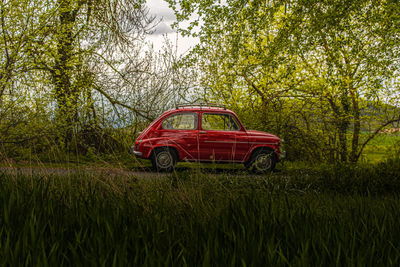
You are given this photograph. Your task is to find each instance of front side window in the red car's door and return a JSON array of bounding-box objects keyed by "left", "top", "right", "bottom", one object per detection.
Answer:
[{"left": 201, "top": 113, "right": 240, "bottom": 131}]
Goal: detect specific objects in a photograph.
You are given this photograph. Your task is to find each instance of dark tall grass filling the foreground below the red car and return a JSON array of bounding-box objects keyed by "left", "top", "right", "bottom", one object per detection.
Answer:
[{"left": 0, "top": 159, "right": 400, "bottom": 266}]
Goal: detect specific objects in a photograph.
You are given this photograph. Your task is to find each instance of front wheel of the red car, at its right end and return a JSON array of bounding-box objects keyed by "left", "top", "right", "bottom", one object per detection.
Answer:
[{"left": 244, "top": 149, "right": 276, "bottom": 174}]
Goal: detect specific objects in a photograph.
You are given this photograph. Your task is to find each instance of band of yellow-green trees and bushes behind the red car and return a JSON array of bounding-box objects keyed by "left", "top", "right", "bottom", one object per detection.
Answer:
[{"left": 0, "top": 0, "right": 400, "bottom": 162}]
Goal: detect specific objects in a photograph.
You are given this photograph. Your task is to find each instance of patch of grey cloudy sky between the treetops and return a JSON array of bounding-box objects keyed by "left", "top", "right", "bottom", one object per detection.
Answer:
[{"left": 147, "top": 0, "right": 198, "bottom": 55}]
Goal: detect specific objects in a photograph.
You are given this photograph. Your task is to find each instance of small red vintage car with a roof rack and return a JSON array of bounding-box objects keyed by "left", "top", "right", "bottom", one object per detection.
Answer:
[{"left": 131, "top": 104, "right": 283, "bottom": 173}]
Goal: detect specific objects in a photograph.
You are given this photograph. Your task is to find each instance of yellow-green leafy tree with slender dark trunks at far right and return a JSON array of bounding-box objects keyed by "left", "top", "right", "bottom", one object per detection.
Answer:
[{"left": 287, "top": 1, "right": 400, "bottom": 162}]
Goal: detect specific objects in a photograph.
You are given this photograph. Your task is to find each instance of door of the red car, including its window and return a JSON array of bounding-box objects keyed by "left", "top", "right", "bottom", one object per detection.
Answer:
[{"left": 199, "top": 112, "right": 248, "bottom": 162}]
